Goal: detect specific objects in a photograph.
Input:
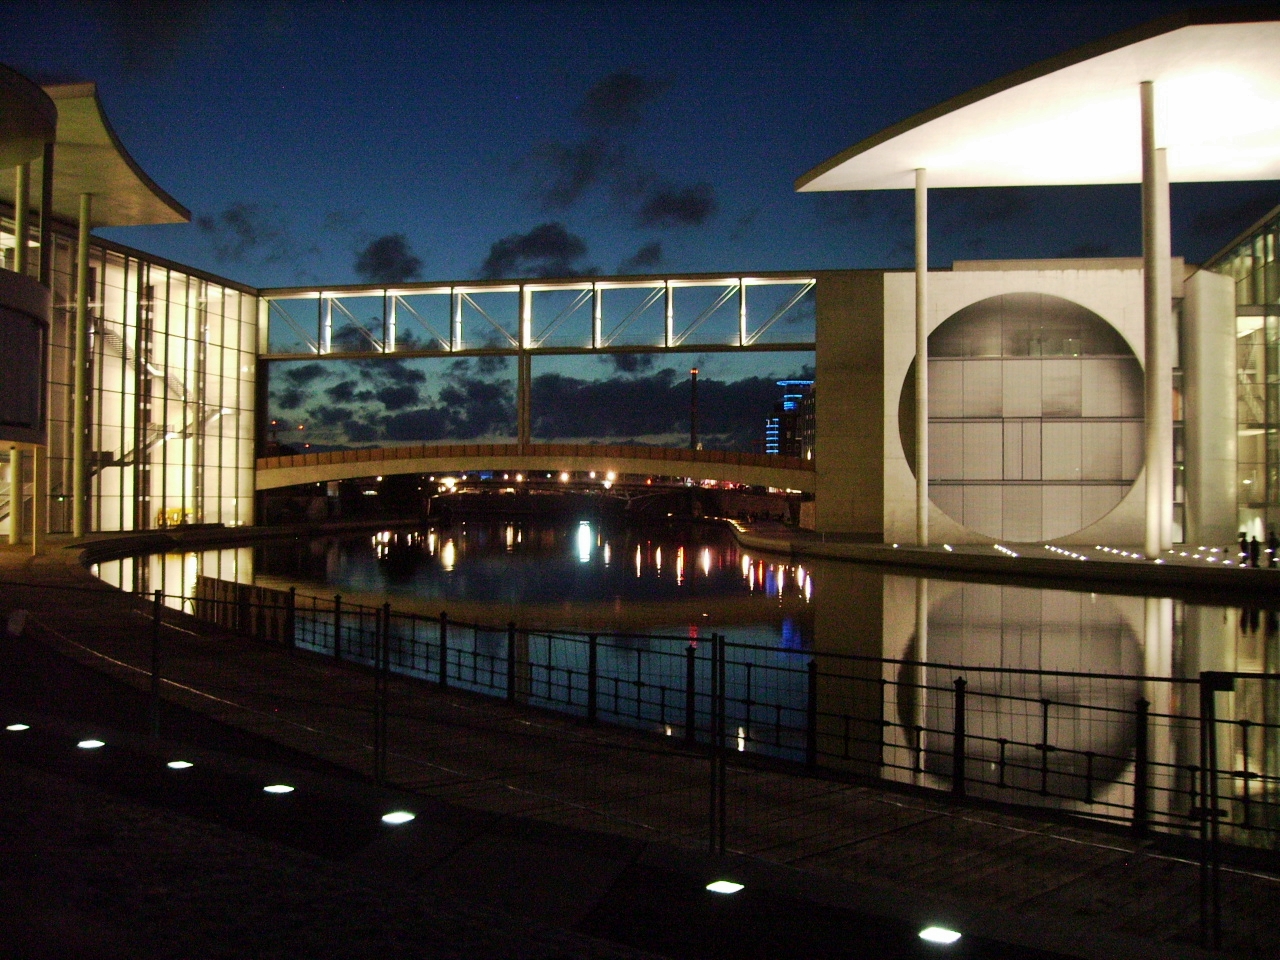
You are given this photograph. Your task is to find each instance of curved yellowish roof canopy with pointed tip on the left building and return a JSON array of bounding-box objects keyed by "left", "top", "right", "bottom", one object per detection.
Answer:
[{"left": 0, "top": 83, "right": 191, "bottom": 227}]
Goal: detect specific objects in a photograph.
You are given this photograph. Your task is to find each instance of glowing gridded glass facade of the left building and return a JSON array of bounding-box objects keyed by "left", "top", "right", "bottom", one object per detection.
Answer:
[{"left": 0, "top": 218, "right": 257, "bottom": 532}]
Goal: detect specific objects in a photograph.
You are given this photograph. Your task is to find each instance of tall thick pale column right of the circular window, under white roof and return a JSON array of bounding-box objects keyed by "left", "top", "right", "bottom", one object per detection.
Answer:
[{"left": 1140, "top": 88, "right": 1174, "bottom": 557}]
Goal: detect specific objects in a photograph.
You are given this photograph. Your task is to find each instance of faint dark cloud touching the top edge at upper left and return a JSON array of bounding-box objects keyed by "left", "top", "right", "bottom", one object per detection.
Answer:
[{"left": 86, "top": 0, "right": 219, "bottom": 73}]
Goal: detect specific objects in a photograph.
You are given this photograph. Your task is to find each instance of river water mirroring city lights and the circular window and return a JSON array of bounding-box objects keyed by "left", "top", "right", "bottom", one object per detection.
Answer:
[{"left": 87, "top": 521, "right": 1280, "bottom": 839}]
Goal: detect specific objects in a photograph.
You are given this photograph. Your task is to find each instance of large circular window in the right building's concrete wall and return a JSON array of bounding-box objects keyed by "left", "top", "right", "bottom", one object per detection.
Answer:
[{"left": 899, "top": 293, "right": 1143, "bottom": 541}]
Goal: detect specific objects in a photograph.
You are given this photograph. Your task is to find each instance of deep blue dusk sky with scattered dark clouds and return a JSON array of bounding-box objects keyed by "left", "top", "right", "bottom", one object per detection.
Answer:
[{"left": 0, "top": 0, "right": 1280, "bottom": 447}]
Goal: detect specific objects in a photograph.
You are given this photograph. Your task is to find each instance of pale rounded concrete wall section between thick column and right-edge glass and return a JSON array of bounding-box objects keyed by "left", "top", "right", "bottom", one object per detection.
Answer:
[{"left": 1181, "top": 270, "right": 1239, "bottom": 547}]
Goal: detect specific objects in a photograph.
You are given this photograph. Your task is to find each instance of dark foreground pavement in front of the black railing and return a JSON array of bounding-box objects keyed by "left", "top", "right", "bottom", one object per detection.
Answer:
[{"left": 0, "top": 537, "right": 1259, "bottom": 960}]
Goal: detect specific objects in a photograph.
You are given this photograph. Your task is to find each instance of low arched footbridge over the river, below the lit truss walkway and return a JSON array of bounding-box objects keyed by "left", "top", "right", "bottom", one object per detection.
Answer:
[{"left": 255, "top": 443, "right": 815, "bottom": 493}]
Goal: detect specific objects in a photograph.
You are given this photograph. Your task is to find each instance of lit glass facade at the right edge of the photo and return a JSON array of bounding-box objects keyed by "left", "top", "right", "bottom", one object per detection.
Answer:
[{"left": 1207, "top": 207, "right": 1280, "bottom": 540}]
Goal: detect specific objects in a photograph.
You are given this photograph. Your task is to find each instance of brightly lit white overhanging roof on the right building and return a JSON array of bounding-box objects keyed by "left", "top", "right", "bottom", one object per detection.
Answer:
[{"left": 796, "top": 8, "right": 1280, "bottom": 191}]
